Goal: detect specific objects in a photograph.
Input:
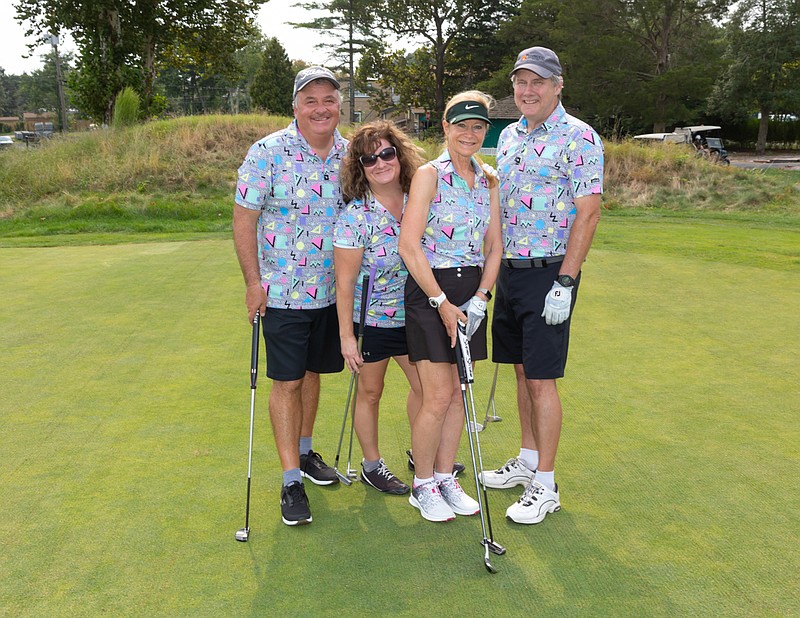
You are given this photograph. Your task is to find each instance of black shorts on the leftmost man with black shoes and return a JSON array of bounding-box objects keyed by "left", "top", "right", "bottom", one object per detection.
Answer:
[{"left": 261, "top": 305, "right": 344, "bottom": 382}]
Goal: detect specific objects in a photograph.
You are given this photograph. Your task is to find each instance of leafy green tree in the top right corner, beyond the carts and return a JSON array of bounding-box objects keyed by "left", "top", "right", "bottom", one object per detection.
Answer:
[{"left": 709, "top": 0, "right": 800, "bottom": 153}]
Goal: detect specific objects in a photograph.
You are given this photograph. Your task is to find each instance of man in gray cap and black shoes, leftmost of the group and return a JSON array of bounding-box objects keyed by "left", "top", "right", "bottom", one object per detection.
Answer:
[{"left": 233, "top": 66, "right": 347, "bottom": 526}]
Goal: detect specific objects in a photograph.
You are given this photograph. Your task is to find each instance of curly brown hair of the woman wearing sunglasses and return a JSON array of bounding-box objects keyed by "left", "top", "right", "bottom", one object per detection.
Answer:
[{"left": 340, "top": 120, "right": 425, "bottom": 202}]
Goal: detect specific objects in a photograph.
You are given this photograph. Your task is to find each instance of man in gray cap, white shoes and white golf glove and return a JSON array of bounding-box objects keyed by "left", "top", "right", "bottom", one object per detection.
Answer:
[{"left": 483, "top": 47, "right": 603, "bottom": 524}]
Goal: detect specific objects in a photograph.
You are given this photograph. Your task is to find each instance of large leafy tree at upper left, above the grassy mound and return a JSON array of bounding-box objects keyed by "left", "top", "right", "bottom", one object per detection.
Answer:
[{"left": 15, "top": 0, "right": 257, "bottom": 121}]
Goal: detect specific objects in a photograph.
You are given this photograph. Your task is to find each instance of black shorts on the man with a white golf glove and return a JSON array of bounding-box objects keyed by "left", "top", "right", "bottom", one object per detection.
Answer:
[{"left": 492, "top": 262, "right": 581, "bottom": 380}]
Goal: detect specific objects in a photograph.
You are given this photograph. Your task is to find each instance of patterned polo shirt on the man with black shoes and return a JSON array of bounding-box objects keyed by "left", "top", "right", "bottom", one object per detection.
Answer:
[{"left": 236, "top": 121, "right": 347, "bottom": 309}]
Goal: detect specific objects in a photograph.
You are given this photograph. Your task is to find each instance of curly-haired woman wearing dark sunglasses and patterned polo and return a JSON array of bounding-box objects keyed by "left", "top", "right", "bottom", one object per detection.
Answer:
[{"left": 333, "top": 121, "right": 424, "bottom": 494}]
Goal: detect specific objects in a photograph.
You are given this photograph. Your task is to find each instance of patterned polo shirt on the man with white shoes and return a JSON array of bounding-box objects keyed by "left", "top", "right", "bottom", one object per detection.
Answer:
[{"left": 497, "top": 103, "right": 603, "bottom": 259}]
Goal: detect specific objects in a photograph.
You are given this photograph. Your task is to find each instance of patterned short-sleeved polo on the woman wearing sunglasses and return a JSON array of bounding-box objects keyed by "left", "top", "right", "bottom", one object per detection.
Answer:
[{"left": 333, "top": 194, "right": 408, "bottom": 328}]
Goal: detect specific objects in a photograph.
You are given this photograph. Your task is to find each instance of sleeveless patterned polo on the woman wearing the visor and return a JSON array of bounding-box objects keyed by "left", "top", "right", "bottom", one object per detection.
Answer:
[{"left": 422, "top": 150, "right": 491, "bottom": 268}]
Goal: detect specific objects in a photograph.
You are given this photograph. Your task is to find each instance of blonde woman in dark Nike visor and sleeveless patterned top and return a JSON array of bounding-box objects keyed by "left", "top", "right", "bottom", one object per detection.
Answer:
[{"left": 400, "top": 91, "right": 502, "bottom": 521}]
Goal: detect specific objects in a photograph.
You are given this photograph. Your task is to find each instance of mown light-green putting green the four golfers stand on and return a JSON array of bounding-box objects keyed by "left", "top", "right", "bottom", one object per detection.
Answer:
[{"left": 0, "top": 217, "right": 800, "bottom": 616}]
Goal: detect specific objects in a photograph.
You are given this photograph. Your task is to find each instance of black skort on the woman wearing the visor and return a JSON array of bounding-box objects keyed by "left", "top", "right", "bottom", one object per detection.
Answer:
[{"left": 405, "top": 266, "right": 487, "bottom": 364}]
